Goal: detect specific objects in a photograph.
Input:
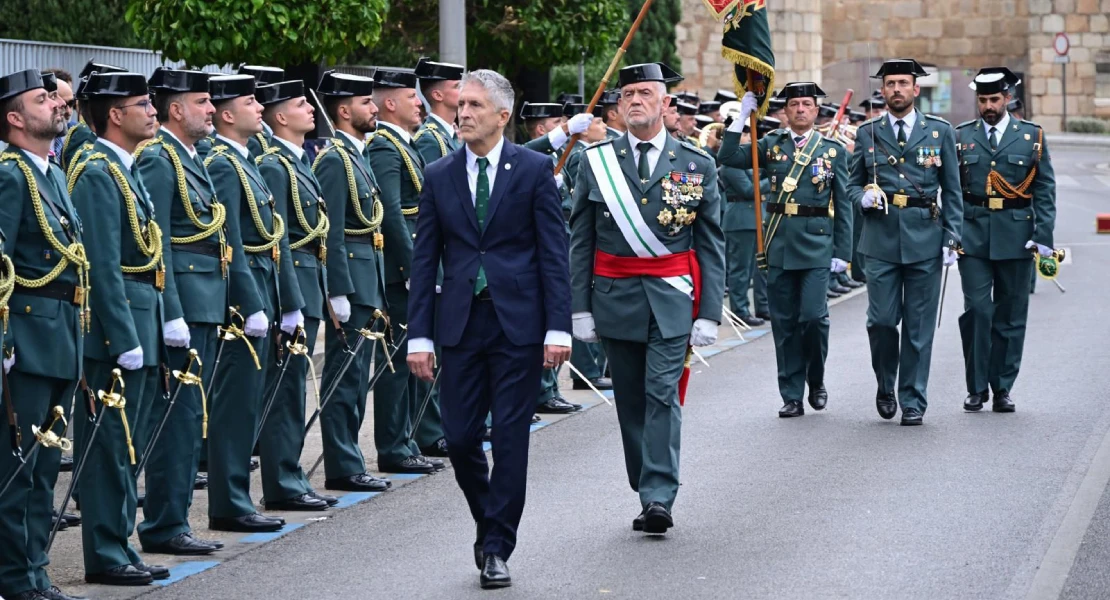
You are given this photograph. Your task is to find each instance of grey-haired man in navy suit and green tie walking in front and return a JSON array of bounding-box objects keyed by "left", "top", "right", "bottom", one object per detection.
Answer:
[{"left": 408, "top": 70, "right": 571, "bottom": 588}]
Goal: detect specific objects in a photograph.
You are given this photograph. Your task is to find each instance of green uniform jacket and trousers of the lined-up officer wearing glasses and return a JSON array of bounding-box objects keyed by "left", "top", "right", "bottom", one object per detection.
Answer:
[{"left": 70, "top": 141, "right": 164, "bottom": 574}]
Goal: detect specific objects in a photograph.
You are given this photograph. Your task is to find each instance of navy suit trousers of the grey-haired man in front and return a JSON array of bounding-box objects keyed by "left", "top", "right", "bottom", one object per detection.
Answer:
[{"left": 441, "top": 299, "right": 544, "bottom": 560}]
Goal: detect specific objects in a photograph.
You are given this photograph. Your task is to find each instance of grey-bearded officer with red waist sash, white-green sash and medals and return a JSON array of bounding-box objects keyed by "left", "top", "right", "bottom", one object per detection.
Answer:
[{"left": 571, "top": 63, "right": 725, "bottom": 535}]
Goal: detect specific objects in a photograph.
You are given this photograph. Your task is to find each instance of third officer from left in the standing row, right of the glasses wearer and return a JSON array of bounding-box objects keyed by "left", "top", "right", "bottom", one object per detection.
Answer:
[{"left": 138, "top": 68, "right": 247, "bottom": 555}]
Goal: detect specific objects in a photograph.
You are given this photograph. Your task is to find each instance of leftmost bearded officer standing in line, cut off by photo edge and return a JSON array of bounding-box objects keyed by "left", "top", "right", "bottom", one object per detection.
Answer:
[{"left": 0, "top": 69, "right": 89, "bottom": 600}]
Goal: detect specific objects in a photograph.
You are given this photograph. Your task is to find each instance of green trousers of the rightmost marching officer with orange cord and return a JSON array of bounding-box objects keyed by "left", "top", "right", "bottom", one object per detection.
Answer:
[{"left": 959, "top": 256, "right": 1035, "bottom": 394}]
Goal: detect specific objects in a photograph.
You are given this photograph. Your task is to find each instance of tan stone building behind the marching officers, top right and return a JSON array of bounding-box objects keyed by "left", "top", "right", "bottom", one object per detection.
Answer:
[{"left": 676, "top": 0, "right": 1110, "bottom": 131}]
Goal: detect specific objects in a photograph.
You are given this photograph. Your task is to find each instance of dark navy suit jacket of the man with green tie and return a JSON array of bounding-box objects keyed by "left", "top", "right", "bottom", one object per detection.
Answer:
[{"left": 406, "top": 140, "right": 571, "bottom": 347}]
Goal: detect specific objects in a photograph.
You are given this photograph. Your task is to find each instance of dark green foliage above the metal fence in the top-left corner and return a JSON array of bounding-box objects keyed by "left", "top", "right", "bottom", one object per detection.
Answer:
[{"left": 0, "top": 0, "right": 142, "bottom": 47}]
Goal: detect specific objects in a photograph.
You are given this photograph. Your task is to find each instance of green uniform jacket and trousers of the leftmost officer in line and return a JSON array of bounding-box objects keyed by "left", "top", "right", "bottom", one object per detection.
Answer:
[{"left": 0, "top": 145, "right": 88, "bottom": 597}]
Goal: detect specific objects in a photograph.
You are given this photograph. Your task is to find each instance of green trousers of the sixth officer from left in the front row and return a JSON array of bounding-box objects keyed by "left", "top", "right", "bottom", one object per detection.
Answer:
[{"left": 320, "top": 304, "right": 379, "bottom": 479}]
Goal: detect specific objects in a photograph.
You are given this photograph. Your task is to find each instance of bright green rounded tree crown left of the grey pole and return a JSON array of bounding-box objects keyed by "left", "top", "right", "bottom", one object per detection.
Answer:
[{"left": 127, "top": 0, "right": 389, "bottom": 65}]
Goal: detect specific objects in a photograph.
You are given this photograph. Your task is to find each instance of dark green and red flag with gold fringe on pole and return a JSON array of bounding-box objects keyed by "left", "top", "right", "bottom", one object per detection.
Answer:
[{"left": 703, "top": 0, "right": 775, "bottom": 116}]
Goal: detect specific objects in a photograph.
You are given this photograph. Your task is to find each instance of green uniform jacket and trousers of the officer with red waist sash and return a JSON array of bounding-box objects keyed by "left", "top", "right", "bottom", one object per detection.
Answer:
[{"left": 571, "top": 131, "right": 725, "bottom": 510}]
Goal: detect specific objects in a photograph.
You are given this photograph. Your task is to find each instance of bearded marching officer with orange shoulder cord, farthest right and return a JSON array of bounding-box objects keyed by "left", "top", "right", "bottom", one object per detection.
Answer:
[{"left": 956, "top": 67, "right": 1056, "bottom": 413}]
